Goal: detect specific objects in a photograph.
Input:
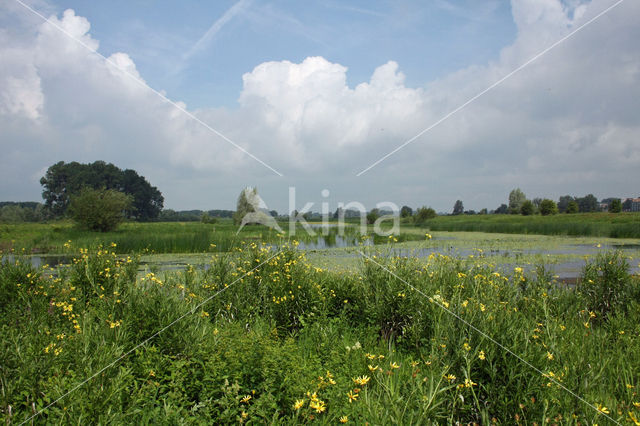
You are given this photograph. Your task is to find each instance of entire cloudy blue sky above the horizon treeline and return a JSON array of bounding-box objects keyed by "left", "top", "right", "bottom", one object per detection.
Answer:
[{"left": 0, "top": 0, "right": 640, "bottom": 212}]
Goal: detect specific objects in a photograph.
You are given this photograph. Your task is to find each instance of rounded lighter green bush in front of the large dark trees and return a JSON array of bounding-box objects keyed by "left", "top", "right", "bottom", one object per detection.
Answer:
[{"left": 69, "top": 187, "right": 132, "bottom": 232}]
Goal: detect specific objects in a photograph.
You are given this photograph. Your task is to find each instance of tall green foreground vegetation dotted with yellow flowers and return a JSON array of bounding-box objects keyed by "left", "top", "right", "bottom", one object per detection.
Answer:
[{"left": 0, "top": 244, "right": 640, "bottom": 424}]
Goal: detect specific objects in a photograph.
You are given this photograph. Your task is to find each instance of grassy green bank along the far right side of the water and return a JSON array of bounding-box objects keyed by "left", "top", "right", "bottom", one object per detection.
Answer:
[{"left": 412, "top": 213, "right": 640, "bottom": 238}]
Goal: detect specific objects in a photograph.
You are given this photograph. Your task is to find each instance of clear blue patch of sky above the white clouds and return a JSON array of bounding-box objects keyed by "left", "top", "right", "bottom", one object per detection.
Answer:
[{"left": 54, "top": 0, "right": 516, "bottom": 108}]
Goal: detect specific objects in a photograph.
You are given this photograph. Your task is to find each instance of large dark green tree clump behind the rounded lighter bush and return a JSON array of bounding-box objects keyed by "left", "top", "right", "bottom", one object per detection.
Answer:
[{"left": 40, "top": 161, "right": 164, "bottom": 220}]
